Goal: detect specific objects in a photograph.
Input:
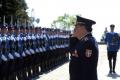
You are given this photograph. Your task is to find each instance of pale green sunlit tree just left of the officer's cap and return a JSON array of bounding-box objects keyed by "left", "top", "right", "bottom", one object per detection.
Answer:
[{"left": 51, "top": 14, "right": 76, "bottom": 29}]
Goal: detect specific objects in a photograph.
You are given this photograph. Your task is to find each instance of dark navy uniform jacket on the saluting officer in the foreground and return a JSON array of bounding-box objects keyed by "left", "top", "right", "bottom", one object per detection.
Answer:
[{"left": 69, "top": 34, "right": 98, "bottom": 80}]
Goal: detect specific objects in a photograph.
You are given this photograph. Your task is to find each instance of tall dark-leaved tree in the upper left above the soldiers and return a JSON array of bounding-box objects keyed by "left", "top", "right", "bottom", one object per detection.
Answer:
[{"left": 0, "top": 0, "right": 28, "bottom": 24}]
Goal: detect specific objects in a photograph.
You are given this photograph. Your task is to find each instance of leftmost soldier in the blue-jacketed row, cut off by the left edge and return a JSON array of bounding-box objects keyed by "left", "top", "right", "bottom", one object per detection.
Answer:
[{"left": 0, "top": 26, "right": 8, "bottom": 80}]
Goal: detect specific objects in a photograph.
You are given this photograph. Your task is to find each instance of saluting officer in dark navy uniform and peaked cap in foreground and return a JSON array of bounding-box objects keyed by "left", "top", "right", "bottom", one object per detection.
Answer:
[{"left": 69, "top": 16, "right": 98, "bottom": 80}]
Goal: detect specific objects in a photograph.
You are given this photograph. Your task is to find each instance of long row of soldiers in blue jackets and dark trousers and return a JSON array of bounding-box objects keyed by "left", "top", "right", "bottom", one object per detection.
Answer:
[{"left": 0, "top": 26, "right": 70, "bottom": 80}]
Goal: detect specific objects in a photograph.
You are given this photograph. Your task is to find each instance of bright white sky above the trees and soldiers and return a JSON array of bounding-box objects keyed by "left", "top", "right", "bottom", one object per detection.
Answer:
[{"left": 26, "top": 0, "right": 120, "bottom": 41}]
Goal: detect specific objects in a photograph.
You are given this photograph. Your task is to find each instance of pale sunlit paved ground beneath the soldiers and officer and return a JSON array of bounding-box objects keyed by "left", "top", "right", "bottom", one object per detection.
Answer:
[{"left": 34, "top": 45, "right": 120, "bottom": 80}]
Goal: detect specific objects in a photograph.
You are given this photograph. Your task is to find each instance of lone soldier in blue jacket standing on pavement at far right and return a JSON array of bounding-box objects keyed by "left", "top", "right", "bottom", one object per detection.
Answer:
[{"left": 105, "top": 24, "right": 120, "bottom": 73}]
